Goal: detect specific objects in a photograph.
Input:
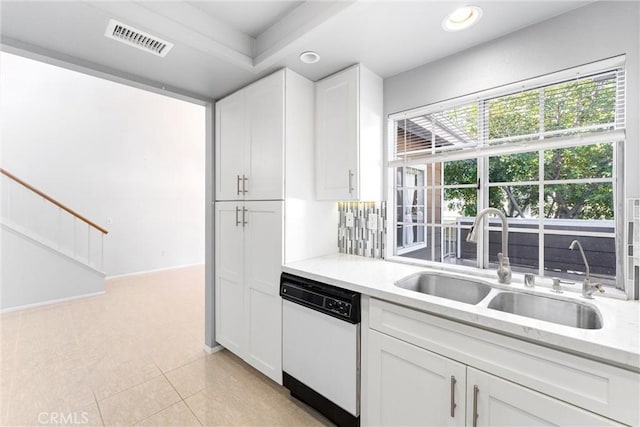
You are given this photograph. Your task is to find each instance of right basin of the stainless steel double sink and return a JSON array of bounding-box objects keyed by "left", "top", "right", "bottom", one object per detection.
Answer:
[{"left": 488, "top": 292, "right": 602, "bottom": 329}]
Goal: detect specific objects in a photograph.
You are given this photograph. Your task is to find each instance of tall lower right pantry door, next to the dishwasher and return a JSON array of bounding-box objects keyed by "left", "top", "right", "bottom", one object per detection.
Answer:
[{"left": 244, "top": 202, "right": 283, "bottom": 384}]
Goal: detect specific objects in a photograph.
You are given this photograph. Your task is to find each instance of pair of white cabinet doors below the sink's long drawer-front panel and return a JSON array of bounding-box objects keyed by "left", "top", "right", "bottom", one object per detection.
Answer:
[{"left": 367, "top": 330, "right": 616, "bottom": 427}]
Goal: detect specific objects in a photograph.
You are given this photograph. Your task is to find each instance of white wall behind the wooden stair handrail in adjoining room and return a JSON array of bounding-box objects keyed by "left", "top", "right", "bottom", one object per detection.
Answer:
[{"left": 0, "top": 52, "right": 205, "bottom": 275}]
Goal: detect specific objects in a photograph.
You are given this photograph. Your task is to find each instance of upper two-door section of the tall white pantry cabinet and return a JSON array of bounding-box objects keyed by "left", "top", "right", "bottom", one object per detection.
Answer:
[{"left": 216, "top": 70, "right": 285, "bottom": 200}]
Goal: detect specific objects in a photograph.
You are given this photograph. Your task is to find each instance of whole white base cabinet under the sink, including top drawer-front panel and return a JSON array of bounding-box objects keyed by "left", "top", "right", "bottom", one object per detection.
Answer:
[{"left": 362, "top": 298, "right": 640, "bottom": 427}]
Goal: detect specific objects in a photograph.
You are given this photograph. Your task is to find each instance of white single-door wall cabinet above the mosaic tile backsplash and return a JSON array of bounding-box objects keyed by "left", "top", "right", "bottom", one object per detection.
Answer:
[{"left": 315, "top": 65, "right": 383, "bottom": 201}]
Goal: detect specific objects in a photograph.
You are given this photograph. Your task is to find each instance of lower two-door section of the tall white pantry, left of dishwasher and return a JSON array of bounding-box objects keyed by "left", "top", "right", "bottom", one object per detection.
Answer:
[{"left": 215, "top": 201, "right": 283, "bottom": 383}]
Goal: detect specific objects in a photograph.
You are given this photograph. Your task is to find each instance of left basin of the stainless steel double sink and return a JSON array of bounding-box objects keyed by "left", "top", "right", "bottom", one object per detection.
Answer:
[{"left": 395, "top": 272, "right": 491, "bottom": 304}]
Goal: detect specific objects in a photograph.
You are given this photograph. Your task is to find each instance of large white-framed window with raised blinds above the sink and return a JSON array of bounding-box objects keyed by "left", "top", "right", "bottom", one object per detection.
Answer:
[{"left": 389, "top": 60, "right": 625, "bottom": 288}]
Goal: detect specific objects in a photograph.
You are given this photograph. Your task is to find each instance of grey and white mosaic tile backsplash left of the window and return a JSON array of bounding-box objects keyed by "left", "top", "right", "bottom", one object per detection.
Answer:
[{"left": 338, "top": 202, "right": 387, "bottom": 258}]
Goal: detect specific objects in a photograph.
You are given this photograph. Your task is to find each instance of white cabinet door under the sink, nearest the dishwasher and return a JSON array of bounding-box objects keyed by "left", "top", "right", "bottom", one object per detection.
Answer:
[{"left": 367, "top": 330, "right": 466, "bottom": 426}]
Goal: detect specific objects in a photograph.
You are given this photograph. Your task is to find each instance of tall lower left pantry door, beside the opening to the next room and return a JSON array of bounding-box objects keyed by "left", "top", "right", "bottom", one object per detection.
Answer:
[{"left": 214, "top": 202, "right": 245, "bottom": 356}]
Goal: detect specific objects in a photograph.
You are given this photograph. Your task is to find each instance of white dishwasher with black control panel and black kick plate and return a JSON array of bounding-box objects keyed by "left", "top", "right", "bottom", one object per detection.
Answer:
[{"left": 280, "top": 273, "right": 360, "bottom": 426}]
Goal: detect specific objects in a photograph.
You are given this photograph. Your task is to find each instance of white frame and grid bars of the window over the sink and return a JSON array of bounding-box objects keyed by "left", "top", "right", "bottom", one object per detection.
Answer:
[{"left": 386, "top": 56, "right": 631, "bottom": 297}]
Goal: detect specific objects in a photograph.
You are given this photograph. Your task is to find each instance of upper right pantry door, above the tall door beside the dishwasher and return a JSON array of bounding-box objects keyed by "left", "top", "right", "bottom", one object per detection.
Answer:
[{"left": 245, "top": 70, "right": 284, "bottom": 200}]
